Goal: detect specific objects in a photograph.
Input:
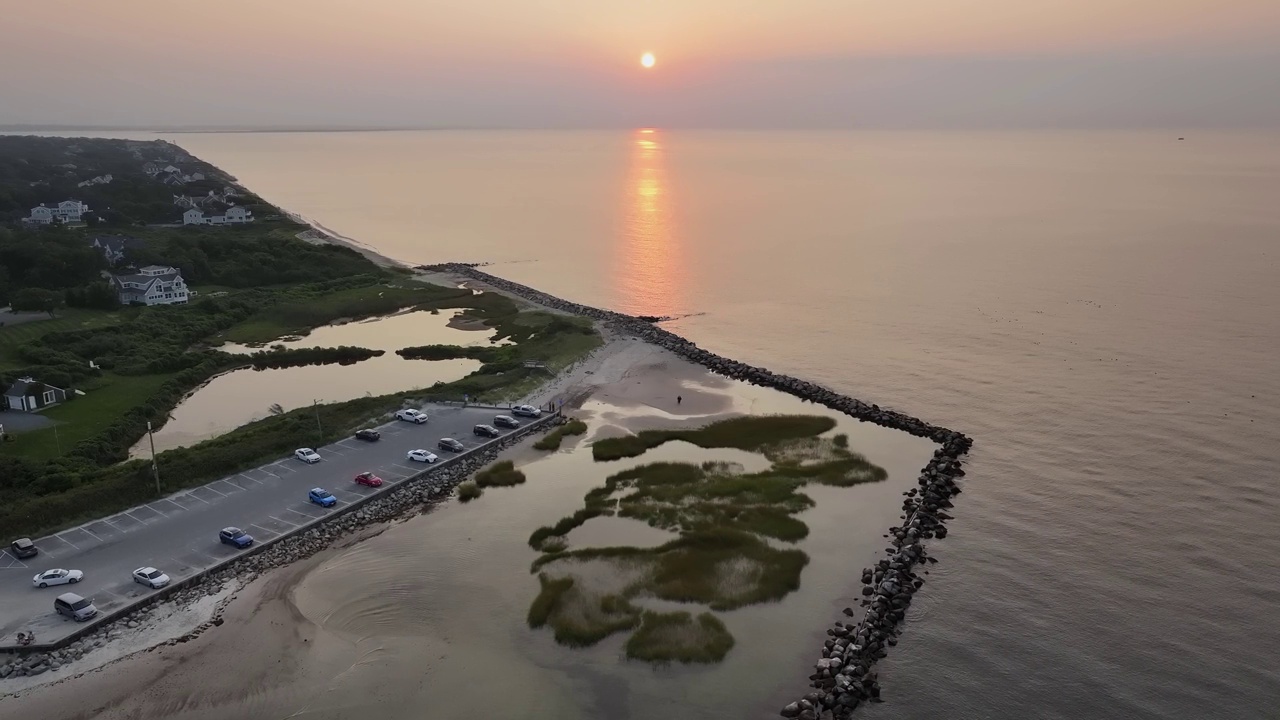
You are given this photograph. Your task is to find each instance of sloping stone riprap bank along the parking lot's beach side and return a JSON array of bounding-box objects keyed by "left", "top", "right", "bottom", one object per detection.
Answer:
[{"left": 0, "top": 427, "right": 545, "bottom": 693}]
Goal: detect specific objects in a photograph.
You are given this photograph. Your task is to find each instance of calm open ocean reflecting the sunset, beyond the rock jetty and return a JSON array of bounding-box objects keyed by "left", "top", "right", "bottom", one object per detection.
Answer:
[{"left": 90, "top": 131, "right": 1280, "bottom": 720}]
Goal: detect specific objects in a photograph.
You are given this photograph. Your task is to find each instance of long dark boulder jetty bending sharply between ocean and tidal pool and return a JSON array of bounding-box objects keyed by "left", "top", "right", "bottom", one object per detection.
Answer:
[{"left": 419, "top": 263, "right": 973, "bottom": 720}]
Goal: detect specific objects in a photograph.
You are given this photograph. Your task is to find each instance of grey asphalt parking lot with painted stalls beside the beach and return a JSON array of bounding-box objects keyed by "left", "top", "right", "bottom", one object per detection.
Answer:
[{"left": 0, "top": 405, "right": 540, "bottom": 646}]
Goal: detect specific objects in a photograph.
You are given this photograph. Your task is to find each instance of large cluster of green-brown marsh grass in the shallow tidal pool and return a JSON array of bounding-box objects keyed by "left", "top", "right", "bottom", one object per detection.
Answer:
[{"left": 529, "top": 415, "right": 887, "bottom": 662}]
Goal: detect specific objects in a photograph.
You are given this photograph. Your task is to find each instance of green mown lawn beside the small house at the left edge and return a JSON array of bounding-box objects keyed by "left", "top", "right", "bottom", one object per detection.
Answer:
[{"left": 4, "top": 373, "right": 177, "bottom": 460}]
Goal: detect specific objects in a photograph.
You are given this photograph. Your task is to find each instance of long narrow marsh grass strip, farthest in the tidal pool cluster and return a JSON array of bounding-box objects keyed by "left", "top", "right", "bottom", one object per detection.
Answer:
[{"left": 591, "top": 415, "right": 836, "bottom": 461}]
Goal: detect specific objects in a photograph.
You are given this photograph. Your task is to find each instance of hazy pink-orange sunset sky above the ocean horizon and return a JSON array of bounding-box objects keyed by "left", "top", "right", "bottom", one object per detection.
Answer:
[{"left": 0, "top": 0, "right": 1280, "bottom": 127}]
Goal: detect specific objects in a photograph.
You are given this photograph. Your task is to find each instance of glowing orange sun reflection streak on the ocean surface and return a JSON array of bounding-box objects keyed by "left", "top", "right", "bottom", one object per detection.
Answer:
[{"left": 613, "top": 128, "right": 687, "bottom": 315}]
